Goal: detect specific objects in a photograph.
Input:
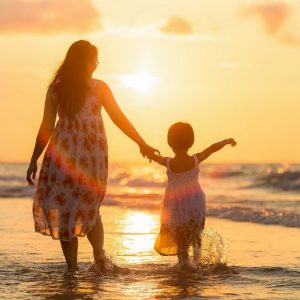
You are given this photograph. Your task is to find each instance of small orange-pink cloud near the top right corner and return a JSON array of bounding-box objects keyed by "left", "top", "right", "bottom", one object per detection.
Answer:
[{"left": 243, "top": 2, "right": 291, "bottom": 35}]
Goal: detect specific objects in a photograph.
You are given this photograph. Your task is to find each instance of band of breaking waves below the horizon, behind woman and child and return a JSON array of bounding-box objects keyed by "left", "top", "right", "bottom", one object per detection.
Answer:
[{"left": 0, "top": 163, "right": 300, "bottom": 228}]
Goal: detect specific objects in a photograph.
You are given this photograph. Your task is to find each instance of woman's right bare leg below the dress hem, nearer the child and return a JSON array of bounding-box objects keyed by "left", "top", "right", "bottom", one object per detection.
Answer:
[{"left": 87, "top": 216, "right": 105, "bottom": 264}]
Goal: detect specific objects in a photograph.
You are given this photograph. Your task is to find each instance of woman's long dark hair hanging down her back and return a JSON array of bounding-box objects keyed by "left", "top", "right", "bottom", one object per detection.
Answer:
[{"left": 48, "top": 40, "right": 98, "bottom": 118}]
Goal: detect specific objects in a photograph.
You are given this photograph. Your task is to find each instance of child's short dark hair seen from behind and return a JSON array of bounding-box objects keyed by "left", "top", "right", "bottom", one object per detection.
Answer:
[{"left": 168, "top": 122, "right": 194, "bottom": 150}]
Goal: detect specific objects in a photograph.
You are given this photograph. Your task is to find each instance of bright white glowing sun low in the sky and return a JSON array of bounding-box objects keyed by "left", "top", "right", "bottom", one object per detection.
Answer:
[{"left": 121, "top": 72, "right": 158, "bottom": 92}]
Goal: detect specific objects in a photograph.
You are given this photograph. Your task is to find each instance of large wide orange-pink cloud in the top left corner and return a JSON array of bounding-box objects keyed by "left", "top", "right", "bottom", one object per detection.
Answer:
[{"left": 0, "top": 0, "right": 101, "bottom": 34}]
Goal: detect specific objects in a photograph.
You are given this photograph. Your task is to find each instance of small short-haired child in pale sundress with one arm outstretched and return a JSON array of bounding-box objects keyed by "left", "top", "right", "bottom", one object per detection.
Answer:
[{"left": 148, "top": 122, "right": 236, "bottom": 266}]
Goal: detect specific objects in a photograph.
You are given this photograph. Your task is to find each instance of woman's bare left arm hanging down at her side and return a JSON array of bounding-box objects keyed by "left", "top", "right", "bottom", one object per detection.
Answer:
[{"left": 27, "top": 89, "right": 57, "bottom": 185}]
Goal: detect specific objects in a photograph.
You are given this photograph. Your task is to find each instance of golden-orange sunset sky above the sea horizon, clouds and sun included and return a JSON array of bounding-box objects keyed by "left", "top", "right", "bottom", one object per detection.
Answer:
[{"left": 0, "top": 0, "right": 300, "bottom": 163}]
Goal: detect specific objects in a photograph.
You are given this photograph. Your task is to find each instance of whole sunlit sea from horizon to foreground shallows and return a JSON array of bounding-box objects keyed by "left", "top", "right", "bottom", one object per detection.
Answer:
[{"left": 0, "top": 163, "right": 300, "bottom": 299}]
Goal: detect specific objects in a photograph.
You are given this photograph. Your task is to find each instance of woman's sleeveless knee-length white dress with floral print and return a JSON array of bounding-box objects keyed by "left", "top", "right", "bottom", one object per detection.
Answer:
[{"left": 33, "top": 80, "right": 108, "bottom": 241}]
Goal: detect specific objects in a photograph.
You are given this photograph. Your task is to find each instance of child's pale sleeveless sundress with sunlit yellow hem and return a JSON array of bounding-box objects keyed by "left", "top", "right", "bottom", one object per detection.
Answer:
[{"left": 154, "top": 155, "right": 206, "bottom": 255}]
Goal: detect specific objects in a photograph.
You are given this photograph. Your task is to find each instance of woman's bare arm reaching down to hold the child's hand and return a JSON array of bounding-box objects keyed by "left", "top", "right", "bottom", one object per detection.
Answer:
[{"left": 97, "top": 80, "right": 157, "bottom": 156}]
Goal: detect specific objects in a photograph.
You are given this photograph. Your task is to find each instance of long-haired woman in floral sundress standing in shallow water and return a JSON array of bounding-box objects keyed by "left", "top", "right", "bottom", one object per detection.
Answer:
[{"left": 27, "top": 40, "right": 156, "bottom": 272}]
